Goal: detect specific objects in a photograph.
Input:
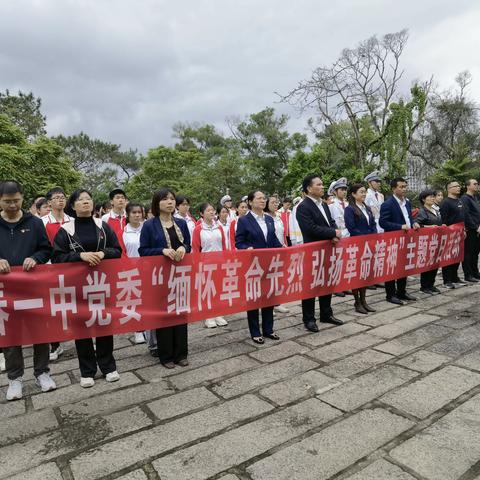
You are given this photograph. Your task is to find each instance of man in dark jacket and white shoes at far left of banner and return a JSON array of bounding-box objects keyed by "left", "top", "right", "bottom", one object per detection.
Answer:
[{"left": 0, "top": 181, "right": 56, "bottom": 400}]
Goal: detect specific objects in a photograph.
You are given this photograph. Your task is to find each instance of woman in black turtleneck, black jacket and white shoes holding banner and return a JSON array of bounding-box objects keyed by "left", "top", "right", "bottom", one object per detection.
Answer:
[{"left": 52, "top": 189, "right": 122, "bottom": 388}]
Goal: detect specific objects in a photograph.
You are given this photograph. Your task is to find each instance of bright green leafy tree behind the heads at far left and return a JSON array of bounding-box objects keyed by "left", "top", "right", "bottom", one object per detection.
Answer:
[{"left": 0, "top": 115, "right": 81, "bottom": 200}]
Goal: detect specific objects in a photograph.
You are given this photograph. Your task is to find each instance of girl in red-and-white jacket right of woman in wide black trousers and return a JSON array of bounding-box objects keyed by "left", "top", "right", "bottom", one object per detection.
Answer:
[{"left": 192, "top": 203, "right": 228, "bottom": 328}]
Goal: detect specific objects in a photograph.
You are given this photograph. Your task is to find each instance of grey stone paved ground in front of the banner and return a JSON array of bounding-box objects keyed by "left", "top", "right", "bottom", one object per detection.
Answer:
[{"left": 0, "top": 281, "right": 480, "bottom": 480}]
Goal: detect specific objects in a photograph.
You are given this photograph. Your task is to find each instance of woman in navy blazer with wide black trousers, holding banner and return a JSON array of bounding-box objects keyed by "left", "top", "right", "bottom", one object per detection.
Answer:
[{"left": 138, "top": 188, "right": 191, "bottom": 368}]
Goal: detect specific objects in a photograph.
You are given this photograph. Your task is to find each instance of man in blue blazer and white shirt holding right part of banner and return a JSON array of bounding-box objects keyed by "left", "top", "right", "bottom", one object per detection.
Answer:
[{"left": 379, "top": 177, "right": 420, "bottom": 305}]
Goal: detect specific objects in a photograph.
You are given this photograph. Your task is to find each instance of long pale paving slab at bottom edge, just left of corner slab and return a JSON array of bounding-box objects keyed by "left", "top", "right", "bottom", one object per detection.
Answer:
[{"left": 248, "top": 409, "right": 413, "bottom": 480}]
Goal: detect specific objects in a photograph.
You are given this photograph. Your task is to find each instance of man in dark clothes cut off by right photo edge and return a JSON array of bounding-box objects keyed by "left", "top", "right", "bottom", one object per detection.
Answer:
[{"left": 460, "top": 182, "right": 480, "bottom": 283}]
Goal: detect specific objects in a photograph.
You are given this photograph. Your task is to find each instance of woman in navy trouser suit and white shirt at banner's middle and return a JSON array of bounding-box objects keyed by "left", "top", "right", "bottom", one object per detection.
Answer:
[{"left": 235, "top": 191, "right": 282, "bottom": 344}]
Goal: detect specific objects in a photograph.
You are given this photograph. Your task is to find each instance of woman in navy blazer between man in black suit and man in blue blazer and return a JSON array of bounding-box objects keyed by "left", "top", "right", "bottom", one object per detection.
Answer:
[{"left": 344, "top": 183, "right": 377, "bottom": 314}]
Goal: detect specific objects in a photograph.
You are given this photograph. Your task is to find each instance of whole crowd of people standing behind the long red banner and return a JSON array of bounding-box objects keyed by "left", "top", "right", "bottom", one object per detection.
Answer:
[{"left": 0, "top": 171, "right": 480, "bottom": 400}]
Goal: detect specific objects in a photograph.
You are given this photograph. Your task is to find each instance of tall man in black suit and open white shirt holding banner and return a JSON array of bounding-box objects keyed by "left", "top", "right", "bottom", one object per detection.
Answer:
[{"left": 297, "top": 174, "right": 343, "bottom": 332}]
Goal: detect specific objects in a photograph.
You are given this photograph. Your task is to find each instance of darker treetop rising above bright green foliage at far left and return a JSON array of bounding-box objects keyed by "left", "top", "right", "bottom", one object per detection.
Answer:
[{"left": 0, "top": 90, "right": 46, "bottom": 140}]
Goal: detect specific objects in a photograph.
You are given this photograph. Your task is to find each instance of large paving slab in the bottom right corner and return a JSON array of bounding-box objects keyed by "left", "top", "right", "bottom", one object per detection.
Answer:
[{"left": 390, "top": 395, "right": 480, "bottom": 480}]
